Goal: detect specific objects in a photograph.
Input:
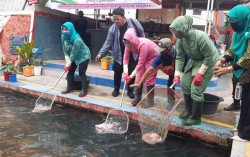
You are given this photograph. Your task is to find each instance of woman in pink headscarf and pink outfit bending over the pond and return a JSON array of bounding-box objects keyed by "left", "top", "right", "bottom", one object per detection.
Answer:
[{"left": 123, "top": 28, "right": 158, "bottom": 105}]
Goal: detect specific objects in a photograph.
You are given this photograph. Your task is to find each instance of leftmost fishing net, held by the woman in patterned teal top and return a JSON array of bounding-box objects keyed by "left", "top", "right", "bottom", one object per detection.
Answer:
[{"left": 32, "top": 71, "right": 65, "bottom": 113}]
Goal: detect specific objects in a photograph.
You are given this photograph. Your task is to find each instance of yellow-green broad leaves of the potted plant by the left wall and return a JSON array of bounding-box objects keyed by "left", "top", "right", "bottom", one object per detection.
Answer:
[{"left": 13, "top": 41, "right": 34, "bottom": 64}]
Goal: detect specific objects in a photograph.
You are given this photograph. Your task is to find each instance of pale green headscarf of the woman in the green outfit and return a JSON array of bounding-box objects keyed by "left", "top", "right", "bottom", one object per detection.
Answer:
[{"left": 169, "top": 15, "right": 193, "bottom": 36}]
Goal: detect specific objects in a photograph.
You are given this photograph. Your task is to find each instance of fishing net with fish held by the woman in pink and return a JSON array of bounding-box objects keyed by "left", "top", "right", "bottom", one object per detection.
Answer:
[{"left": 95, "top": 83, "right": 129, "bottom": 134}]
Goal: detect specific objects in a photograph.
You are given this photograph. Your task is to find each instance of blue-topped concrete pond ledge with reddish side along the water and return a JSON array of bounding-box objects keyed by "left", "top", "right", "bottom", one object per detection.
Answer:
[{"left": 0, "top": 79, "right": 233, "bottom": 147}]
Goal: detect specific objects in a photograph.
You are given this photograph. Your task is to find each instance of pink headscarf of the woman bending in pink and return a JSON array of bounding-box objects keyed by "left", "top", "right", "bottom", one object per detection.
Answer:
[{"left": 123, "top": 28, "right": 142, "bottom": 54}]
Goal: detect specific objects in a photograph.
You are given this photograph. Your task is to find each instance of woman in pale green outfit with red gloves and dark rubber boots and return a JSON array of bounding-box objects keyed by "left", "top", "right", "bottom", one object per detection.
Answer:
[{"left": 169, "top": 15, "right": 219, "bottom": 125}]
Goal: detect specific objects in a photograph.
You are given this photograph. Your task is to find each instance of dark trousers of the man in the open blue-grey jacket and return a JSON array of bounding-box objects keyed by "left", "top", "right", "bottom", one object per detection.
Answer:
[{"left": 113, "top": 57, "right": 137, "bottom": 89}]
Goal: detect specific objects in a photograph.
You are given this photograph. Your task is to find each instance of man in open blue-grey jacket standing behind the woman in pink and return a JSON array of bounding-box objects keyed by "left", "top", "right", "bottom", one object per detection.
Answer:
[{"left": 96, "top": 7, "right": 145, "bottom": 99}]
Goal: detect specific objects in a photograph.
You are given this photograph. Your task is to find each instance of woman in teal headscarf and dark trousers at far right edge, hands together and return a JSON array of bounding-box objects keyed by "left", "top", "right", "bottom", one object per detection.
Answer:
[{"left": 214, "top": 5, "right": 250, "bottom": 140}]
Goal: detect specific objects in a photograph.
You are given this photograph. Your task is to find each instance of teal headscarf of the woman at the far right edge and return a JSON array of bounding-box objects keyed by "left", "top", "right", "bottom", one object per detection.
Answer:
[{"left": 227, "top": 5, "right": 250, "bottom": 78}]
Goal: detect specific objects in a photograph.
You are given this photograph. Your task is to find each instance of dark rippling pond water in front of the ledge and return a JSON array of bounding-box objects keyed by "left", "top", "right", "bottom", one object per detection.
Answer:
[{"left": 0, "top": 88, "right": 231, "bottom": 157}]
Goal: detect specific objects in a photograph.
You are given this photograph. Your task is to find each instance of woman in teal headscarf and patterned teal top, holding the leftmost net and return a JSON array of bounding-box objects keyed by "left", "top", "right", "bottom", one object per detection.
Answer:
[{"left": 61, "top": 22, "right": 90, "bottom": 97}]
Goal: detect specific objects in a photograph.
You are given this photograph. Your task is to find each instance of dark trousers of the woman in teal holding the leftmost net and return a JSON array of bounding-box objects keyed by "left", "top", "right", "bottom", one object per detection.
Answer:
[{"left": 68, "top": 59, "right": 89, "bottom": 78}]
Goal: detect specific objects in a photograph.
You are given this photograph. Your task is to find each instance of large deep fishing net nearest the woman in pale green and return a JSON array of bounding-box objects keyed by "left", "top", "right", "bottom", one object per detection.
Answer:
[{"left": 136, "top": 88, "right": 181, "bottom": 144}]
